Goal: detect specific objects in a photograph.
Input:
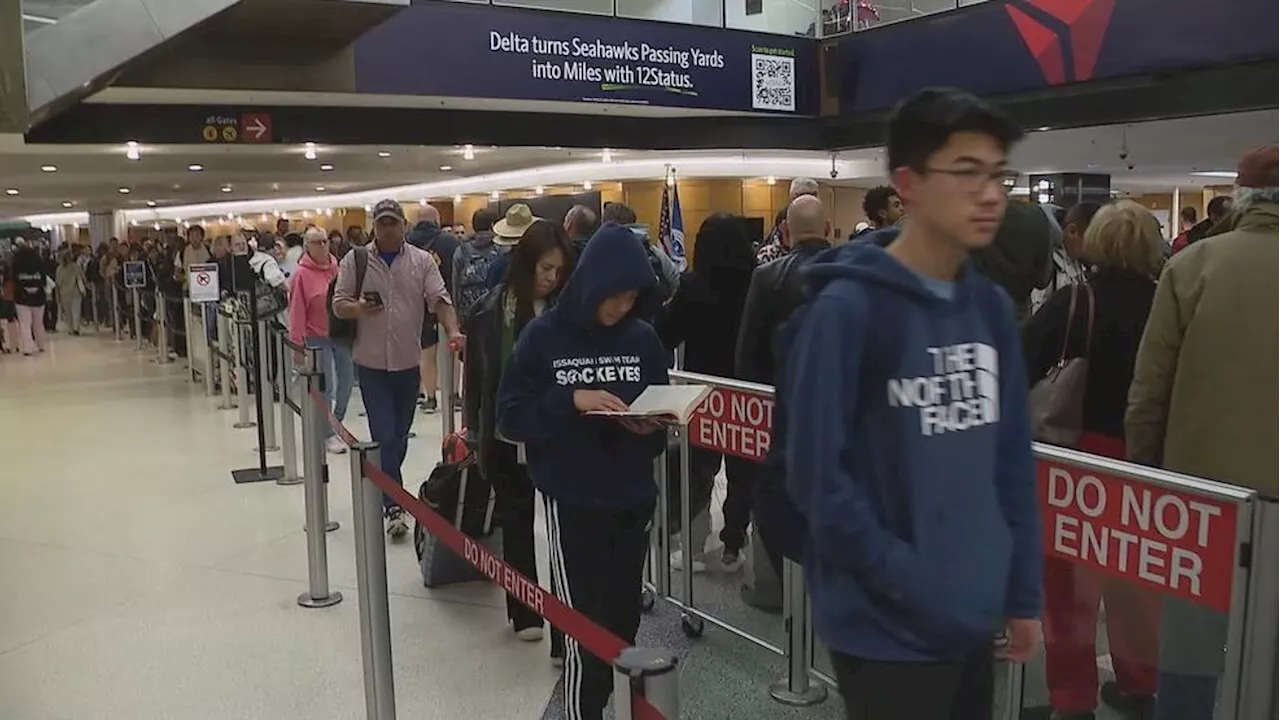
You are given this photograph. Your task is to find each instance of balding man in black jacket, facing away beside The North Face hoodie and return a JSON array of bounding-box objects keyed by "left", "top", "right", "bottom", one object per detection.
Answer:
[{"left": 735, "top": 195, "right": 831, "bottom": 609}]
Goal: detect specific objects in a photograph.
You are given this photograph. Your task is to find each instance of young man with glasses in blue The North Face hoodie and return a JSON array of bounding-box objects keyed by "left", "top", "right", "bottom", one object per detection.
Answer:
[{"left": 780, "top": 90, "right": 1042, "bottom": 720}]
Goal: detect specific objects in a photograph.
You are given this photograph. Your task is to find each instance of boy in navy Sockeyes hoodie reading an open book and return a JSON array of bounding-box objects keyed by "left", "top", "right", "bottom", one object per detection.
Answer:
[{"left": 498, "top": 223, "right": 668, "bottom": 720}]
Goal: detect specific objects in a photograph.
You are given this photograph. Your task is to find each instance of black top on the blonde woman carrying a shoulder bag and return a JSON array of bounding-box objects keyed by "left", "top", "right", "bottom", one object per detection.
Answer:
[{"left": 1023, "top": 270, "right": 1156, "bottom": 439}]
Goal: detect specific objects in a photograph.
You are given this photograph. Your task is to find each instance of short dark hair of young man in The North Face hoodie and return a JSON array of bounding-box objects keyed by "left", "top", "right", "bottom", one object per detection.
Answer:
[{"left": 886, "top": 87, "right": 1023, "bottom": 172}]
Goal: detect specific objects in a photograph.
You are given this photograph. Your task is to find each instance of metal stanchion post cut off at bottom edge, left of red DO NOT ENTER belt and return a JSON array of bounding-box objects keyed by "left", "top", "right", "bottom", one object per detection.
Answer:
[{"left": 350, "top": 442, "right": 396, "bottom": 720}]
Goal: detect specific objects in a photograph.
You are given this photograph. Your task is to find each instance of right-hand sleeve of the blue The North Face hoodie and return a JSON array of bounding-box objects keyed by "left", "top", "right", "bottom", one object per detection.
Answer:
[{"left": 991, "top": 288, "right": 1044, "bottom": 619}]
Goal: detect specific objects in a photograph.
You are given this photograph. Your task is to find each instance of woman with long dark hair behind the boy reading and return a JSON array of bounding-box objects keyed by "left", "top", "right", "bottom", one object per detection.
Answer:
[{"left": 463, "top": 220, "right": 573, "bottom": 659}]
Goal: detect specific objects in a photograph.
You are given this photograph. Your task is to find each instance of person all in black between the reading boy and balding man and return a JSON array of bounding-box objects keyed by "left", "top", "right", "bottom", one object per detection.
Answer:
[{"left": 657, "top": 213, "right": 755, "bottom": 573}]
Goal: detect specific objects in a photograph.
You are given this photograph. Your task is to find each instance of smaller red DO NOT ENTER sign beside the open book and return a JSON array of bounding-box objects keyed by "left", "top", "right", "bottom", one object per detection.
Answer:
[{"left": 689, "top": 387, "right": 773, "bottom": 461}]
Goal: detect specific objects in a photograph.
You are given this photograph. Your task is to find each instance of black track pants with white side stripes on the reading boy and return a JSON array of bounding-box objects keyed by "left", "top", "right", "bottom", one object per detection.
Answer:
[{"left": 547, "top": 497, "right": 653, "bottom": 720}]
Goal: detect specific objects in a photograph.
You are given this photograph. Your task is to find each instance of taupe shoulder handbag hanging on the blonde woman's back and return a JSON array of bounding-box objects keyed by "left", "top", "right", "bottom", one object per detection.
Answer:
[{"left": 1029, "top": 282, "right": 1094, "bottom": 447}]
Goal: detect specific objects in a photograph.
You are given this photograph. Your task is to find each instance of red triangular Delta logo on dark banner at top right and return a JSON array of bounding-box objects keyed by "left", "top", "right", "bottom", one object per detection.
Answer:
[{"left": 1005, "top": 0, "right": 1116, "bottom": 85}]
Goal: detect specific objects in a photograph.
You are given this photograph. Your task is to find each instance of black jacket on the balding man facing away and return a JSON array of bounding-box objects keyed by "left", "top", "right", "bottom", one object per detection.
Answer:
[{"left": 733, "top": 240, "right": 831, "bottom": 384}]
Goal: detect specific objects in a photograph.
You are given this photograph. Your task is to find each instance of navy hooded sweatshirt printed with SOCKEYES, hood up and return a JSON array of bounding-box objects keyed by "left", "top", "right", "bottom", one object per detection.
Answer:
[{"left": 498, "top": 223, "right": 669, "bottom": 507}]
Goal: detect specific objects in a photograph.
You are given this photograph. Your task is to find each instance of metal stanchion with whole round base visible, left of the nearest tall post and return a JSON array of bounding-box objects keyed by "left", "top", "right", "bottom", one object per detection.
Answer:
[{"left": 295, "top": 372, "right": 343, "bottom": 607}]
